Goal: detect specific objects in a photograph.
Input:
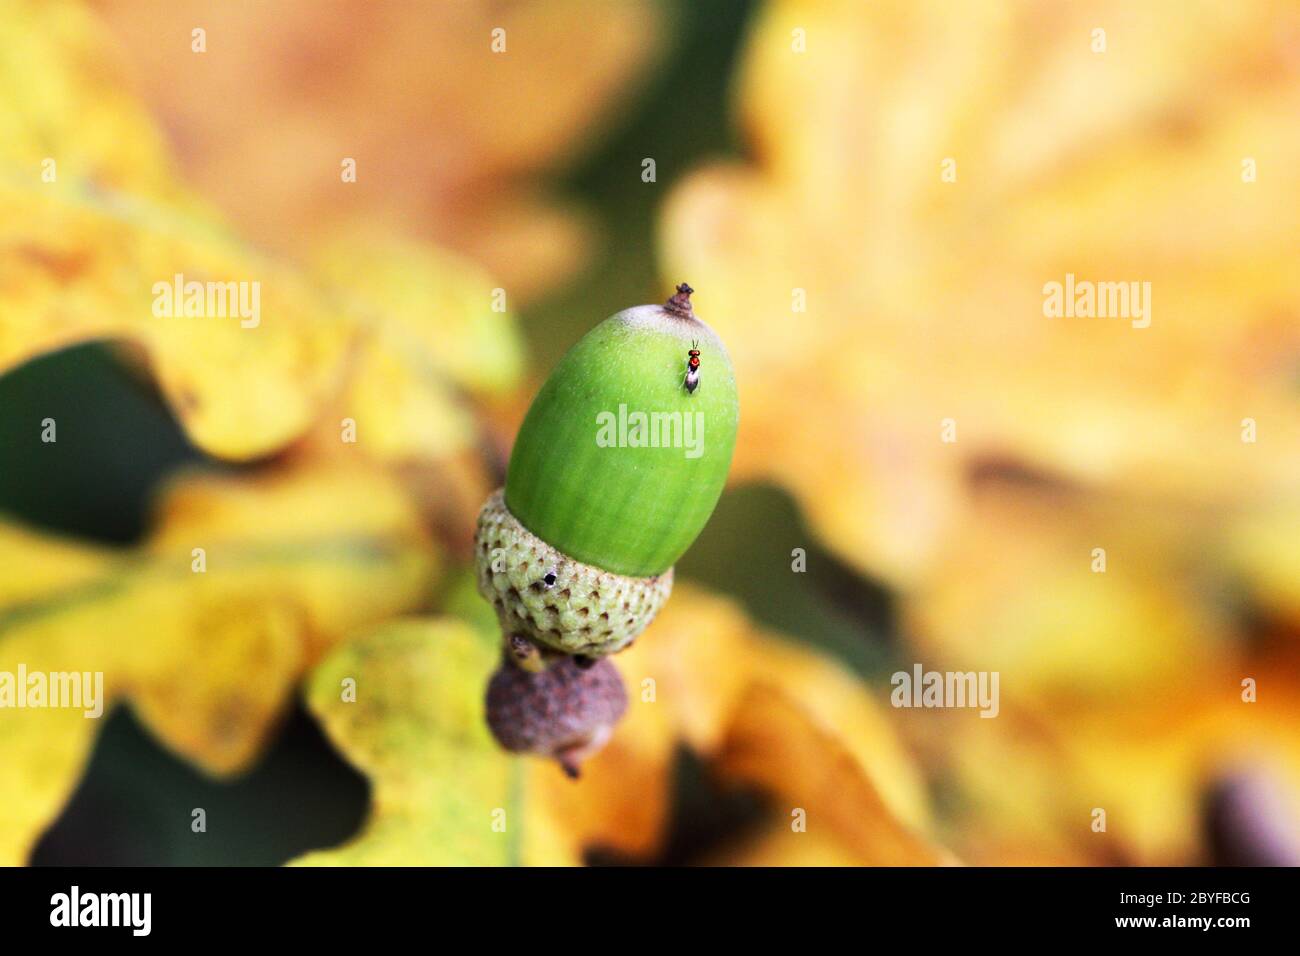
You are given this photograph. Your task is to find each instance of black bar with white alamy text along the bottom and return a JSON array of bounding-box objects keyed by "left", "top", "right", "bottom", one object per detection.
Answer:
[{"left": 0, "top": 868, "right": 1279, "bottom": 946}]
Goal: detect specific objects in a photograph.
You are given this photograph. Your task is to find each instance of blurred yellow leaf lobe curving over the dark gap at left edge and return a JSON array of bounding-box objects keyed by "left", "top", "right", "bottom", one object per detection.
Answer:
[{"left": 0, "top": 182, "right": 352, "bottom": 459}]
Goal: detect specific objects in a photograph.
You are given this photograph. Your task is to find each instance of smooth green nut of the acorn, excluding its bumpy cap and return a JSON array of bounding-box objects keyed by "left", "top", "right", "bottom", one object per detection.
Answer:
[{"left": 504, "top": 284, "right": 738, "bottom": 578}]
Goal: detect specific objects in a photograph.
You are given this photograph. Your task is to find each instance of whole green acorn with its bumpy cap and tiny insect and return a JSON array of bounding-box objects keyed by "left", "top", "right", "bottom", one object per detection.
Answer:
[{"left": 475, "top": 284, "right": 738, "bottom": 770}]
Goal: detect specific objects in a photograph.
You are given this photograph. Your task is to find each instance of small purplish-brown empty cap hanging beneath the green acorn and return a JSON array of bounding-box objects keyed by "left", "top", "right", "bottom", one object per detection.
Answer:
[{"left": 488, "top": 657, "right": 628, "bottom": 777}]
